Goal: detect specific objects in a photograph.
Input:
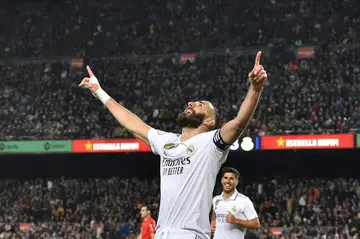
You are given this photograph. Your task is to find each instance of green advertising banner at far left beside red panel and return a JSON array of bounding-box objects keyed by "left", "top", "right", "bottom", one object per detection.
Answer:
[{"left": 0, "top": 140, "right": 72, "bottom": 154}]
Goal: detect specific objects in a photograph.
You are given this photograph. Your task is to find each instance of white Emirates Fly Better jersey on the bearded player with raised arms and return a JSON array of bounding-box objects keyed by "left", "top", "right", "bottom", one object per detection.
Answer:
[{"left": 148, "top": 129, "right": 230, "bottom": 238}]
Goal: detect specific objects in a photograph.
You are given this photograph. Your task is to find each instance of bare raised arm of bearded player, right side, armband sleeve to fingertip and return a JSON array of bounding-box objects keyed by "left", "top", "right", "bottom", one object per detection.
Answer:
[{"left": 220, "top": 51, "right": 267, "bottom": 144}]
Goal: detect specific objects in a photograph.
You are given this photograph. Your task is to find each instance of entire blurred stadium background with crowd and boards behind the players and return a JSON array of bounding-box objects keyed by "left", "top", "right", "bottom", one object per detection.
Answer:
[{"left": 0, "top": 0, "right": 360, "bottom": 239}]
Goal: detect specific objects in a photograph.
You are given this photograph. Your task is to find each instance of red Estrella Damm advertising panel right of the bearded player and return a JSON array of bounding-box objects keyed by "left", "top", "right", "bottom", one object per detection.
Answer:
[{"left": 261, "top": 134, "right": 354, "bottom": 150}]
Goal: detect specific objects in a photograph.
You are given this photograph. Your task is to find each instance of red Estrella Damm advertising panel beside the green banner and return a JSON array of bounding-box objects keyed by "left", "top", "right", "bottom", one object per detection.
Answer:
[{"left": 72, "top": 139, "right": 151, "bottom": 153}]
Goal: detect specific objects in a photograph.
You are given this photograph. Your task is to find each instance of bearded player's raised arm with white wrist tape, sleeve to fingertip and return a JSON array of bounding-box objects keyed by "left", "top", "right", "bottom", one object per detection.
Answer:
[{"left": 79, "top": 66, "right": 150, "bottom": 144}]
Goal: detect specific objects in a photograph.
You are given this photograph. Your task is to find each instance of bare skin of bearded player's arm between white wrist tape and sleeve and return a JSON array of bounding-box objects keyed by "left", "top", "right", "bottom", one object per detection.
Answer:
[{"left": 105, "top": 98, "right": 150, "bottom": 142}]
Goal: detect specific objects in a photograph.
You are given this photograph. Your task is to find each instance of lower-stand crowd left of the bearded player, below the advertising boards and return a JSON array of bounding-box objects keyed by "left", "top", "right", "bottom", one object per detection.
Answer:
[{"left": 0, "top": 178, "right": 160, "bottom": 239}]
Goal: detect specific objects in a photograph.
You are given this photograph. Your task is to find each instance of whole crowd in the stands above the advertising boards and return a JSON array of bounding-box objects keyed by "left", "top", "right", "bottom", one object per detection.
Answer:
[{"left": 0, "top": 0, "right": 360, "bottom": 140}]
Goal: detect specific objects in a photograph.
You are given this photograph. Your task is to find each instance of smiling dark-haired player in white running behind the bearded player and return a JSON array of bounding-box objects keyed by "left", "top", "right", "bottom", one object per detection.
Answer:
[{"left": 211, "top": 168, "right": 260, "bottom": 239}]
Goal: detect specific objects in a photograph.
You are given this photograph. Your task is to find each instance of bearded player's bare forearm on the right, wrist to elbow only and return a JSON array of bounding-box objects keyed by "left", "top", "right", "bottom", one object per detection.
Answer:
[{"left": 235, "top": 85, "right": 262, "bottom": 130}]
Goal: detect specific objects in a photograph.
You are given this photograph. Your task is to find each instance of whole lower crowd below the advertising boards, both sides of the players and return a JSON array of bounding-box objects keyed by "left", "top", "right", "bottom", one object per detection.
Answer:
[{"left": 0, "top": 178, "right": 360, "bottom": 239}]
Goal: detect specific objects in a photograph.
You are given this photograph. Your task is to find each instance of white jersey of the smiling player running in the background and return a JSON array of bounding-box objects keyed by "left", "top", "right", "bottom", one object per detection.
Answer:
[{"left": 213, "top": 191, "right": 258, "bottom": 239}]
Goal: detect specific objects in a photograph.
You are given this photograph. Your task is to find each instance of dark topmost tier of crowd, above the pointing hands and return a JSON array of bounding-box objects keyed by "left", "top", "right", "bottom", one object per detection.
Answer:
[{"left": 0, "top": 0, "right": 359, "bottom": 57}]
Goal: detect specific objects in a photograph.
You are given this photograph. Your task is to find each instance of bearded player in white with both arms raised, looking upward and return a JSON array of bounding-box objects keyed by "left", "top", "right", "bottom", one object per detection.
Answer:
[{"left": 80, "top": 52, "right": 267, "bottom": 239}]
